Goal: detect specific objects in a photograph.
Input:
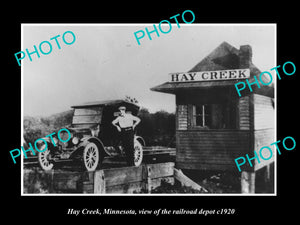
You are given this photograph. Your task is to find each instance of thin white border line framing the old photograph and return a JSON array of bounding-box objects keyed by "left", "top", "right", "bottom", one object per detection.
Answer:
[{"left": 20, "top": 23, "right": 277, "bottom": 197}]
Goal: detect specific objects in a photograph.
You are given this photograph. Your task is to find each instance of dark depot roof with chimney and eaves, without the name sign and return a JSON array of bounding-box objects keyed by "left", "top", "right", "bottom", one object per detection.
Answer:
[{"left": 151, "top": 42, "right": 274, "bottom": 98}]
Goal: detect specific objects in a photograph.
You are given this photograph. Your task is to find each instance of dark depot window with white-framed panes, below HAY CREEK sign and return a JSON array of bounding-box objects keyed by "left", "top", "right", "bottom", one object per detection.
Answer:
[{"left": 191, "top": 104, "right": 236, "bottom": 129}]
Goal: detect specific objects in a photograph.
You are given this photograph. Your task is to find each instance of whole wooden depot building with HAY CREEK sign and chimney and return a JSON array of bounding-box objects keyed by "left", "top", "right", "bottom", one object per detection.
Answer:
[{"left": 151, "top": 42, "right": 275, "bottom": 192}]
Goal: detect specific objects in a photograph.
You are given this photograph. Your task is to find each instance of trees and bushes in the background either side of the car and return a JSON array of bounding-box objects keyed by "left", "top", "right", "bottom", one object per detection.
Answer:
[{"left": 24, "top": 108, "right": 175, "bottom": 147}]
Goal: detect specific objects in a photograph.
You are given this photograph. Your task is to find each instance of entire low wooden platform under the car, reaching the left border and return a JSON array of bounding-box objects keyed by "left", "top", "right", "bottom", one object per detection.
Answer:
[{"left": 23, "top": 162, "right": 174, "bottom": 194}]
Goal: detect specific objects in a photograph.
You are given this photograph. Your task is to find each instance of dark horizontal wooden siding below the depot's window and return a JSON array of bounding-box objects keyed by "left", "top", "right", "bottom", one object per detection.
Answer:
[{"left": 176, "top": 130, "right": 250, "bottom": 170}]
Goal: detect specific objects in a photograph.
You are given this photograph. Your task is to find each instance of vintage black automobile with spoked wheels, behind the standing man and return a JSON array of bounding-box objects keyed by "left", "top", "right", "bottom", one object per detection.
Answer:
[{"left": 38, "top": 100, "right": 145, "bottom": 171}]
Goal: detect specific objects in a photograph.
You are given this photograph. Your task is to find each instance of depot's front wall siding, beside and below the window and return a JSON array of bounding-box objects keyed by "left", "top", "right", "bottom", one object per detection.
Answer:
[{"left": 176, "top": 96, "right": 251, "bottom": 170}]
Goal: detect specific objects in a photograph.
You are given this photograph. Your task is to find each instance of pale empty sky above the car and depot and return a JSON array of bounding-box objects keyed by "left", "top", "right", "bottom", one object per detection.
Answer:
[{"left": 21, "top": 23, "right": 276, "bottom": 116}]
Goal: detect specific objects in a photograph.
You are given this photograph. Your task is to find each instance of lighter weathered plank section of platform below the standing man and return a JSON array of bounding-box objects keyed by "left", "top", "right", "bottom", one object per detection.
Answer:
[{"left": 92, "top": 162, "right": 174, "bottom": 194}]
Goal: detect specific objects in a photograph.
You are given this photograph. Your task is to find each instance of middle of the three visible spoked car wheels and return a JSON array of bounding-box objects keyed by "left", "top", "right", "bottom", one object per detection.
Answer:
[{"left": 83, "top": 142, "right": 100, "bottom": 171}]
